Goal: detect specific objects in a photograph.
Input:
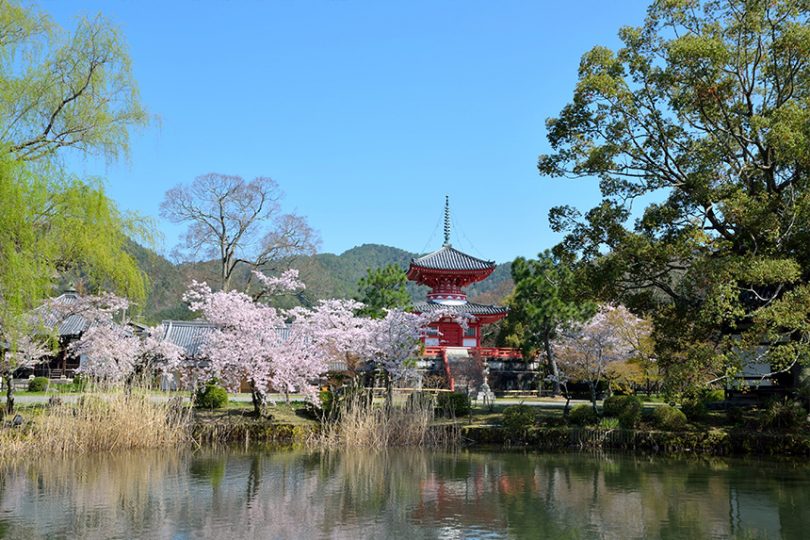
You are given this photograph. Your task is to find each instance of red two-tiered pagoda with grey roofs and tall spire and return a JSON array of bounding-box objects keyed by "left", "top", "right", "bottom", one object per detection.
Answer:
[{"left": 407, "top": 197, "right": 508, "bottom": 348}]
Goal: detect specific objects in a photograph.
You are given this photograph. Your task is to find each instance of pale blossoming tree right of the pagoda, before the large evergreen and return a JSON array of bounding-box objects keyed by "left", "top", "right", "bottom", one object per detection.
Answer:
[{"left": 553, "top": 305, "right": 649, "bottom": 411}]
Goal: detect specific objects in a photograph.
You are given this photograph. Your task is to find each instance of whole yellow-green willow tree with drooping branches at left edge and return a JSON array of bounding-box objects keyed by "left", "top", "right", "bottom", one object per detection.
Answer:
[{"left": 0, "top": 0, "right": 148, "bottom": 405}]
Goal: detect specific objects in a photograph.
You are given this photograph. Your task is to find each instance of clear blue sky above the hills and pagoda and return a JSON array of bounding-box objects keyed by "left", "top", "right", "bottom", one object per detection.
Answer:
[{"left": 44, "top": 0, "right": 648, "bottom": 262}]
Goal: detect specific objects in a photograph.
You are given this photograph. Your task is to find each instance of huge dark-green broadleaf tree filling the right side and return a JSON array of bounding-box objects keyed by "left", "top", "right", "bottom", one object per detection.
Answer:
[{"left": 539, "top": 0, "right": 810, "bottom": 389}]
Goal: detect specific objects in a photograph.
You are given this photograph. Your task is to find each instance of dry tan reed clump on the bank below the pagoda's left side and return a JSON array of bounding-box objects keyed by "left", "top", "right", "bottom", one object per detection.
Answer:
[{"left": 308, "top": 394, "right": 460, "bottom": 449}]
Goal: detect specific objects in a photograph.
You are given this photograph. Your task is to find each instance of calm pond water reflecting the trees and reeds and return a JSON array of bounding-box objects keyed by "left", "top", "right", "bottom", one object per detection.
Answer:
[{"left": 0, "top": 450, "right": 810, "bottom": 539}]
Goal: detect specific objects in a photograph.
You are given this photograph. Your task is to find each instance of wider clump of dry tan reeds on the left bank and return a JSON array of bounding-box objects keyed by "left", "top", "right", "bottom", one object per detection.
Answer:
[{"left": 0, "top": 389, "right": 192, "bottom": 462}]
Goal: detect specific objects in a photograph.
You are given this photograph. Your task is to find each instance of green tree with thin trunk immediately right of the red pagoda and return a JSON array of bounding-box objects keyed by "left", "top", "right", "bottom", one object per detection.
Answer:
[{"left": 501, "top": 251, "right": 596, "bottom": 395}]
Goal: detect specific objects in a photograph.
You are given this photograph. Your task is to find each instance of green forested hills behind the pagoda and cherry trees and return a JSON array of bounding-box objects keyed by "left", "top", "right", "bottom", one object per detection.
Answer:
[{"left": 128, "top": 244, "right": 512, "bottom": 322}]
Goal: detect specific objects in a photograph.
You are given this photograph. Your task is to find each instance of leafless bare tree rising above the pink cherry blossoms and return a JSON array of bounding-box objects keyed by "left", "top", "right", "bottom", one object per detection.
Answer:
[{"left": 160, "top": 173, "right": 319, "bottom": 290}]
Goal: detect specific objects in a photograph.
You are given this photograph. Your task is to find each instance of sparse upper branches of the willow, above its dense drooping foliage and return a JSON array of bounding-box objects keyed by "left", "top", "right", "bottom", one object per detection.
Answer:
[{"left": 0, "top": 0, "right": 148, "bottom": 161}]
